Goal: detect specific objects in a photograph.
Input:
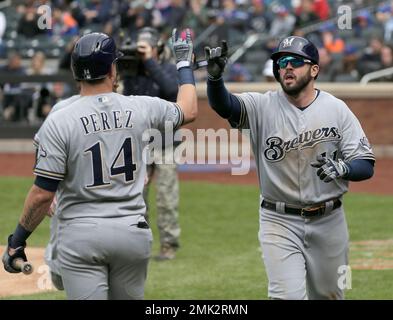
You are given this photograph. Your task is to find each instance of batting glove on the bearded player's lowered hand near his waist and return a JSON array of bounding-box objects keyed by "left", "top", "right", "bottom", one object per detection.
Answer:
[{"left": 311, "top": 155, "right": 349, "bottom": 182}]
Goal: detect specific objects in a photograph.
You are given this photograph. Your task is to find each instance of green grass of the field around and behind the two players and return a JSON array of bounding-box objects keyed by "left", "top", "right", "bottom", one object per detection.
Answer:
[{"left": 0, "top": 178, "right": 393, "bottom": 300}]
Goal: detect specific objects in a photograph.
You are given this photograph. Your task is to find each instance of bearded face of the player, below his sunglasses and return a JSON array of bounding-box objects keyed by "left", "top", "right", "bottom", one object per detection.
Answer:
[{"left": 280, "top": 65, "right": 313, "bottom": 96}]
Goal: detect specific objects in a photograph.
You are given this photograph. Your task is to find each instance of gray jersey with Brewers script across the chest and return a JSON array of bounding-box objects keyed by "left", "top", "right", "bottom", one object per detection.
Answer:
[{"left": 236, "top": 90, "right": 374, "bottom": 206}]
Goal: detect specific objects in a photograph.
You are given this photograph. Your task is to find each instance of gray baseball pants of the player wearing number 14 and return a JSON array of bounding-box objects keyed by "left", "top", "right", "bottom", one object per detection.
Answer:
[{"left": 58, "top": 216, "right": 153, "bottom": 300}]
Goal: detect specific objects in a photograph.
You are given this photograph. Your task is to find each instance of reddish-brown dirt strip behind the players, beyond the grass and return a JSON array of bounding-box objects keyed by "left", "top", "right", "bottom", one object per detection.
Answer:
[{"left": 0, "top": 153, "right": 393, "bottom": 195}]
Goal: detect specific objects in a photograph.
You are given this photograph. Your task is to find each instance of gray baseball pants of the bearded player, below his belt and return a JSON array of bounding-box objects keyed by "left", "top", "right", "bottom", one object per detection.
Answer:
[{"left": 259, "top": 206, "right": 349, "bottom": 300}]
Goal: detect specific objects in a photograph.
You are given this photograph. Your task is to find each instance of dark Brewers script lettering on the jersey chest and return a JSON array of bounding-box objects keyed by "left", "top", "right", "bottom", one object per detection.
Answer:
[{"left": 264, "top": 127, "right": 341, "bottom": 162}]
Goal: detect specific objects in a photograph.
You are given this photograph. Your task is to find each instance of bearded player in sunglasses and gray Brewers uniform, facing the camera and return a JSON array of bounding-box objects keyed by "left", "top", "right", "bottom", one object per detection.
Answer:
[{"left": 205, "top": 36, "right": 375, "bottom": 299}]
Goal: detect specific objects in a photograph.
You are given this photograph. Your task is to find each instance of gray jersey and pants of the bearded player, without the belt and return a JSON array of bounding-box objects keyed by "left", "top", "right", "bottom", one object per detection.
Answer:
[{"left": 231, "top": 90, "right": 374, "bottom": 299}]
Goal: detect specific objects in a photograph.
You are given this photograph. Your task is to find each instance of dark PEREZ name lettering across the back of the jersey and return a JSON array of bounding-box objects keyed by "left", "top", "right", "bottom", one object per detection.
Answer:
[{"left": 79, "top": 110, "right": 132, "bottom": 135}]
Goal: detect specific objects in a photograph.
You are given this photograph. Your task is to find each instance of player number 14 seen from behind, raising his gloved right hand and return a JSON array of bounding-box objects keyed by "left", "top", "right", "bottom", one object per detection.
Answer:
[{"left": 2, "top": 30, "right": 197, "bottom": 299}]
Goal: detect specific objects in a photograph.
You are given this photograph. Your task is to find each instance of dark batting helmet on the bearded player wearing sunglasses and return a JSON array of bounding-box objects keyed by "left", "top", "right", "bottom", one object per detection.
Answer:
[{"left": 270, "top": 36, "right": 319, "bottom": 81}]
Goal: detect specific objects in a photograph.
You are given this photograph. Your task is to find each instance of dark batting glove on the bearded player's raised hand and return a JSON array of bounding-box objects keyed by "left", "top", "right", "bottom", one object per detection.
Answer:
[{"left": 205, "top": 40, "right": 228, "bottom": 80}]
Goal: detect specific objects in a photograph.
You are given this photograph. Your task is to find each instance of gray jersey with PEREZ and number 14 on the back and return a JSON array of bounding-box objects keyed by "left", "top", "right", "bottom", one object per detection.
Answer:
[{"left": 34, "top": 93, "right": 183, "bottom": 219}]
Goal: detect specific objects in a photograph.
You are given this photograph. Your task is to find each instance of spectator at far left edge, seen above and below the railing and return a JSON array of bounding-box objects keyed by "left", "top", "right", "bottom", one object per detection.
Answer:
[{"left": 0, "top": 51, "right": 29, "bottom": 121}]
